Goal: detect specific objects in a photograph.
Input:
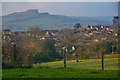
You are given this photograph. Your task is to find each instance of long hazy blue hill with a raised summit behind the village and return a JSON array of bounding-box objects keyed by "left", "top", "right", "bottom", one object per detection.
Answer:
[{"left": 2, "top": 9, "right": 112, "bottom": 30}]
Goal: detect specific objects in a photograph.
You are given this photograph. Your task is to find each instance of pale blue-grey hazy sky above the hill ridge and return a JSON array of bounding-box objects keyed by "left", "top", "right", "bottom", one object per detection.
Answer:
[{"left": 0, "top": 0, "right": 118, "bottom": 17}]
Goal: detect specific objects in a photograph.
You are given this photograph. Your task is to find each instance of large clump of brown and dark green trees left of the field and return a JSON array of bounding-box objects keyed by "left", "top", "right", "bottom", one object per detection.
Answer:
[{"left": 2, "top": 28, "right": 59, "bottom": 68}]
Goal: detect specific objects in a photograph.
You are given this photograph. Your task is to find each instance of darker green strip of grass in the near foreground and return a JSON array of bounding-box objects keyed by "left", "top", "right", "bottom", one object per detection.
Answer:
[{"left": 3, "top": 67, "right": 118, "bottom": 78}]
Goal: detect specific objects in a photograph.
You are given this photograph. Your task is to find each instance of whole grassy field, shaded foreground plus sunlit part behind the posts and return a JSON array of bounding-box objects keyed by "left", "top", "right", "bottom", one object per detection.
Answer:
[{"left": 2, "top": 54, "right": 119, "bottom": 78}]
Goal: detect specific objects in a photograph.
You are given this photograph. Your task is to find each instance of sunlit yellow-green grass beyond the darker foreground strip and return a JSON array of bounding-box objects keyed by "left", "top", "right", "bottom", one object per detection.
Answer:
[{"left": 34, "top": 58, "right": 118, "bottom": 70}]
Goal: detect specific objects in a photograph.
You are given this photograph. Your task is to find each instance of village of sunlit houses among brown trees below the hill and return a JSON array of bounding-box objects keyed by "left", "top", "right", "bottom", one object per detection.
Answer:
[{"left": 2, "top": 16, "right": 119, "bottom": 60}]
